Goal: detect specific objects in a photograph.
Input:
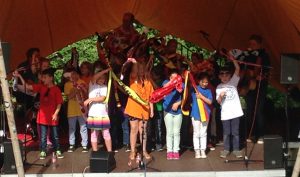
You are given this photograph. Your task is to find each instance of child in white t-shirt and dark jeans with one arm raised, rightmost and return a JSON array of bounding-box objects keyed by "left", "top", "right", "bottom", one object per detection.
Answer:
[{"left": 216, "top": 60, "right": 244, "bottom": 158}]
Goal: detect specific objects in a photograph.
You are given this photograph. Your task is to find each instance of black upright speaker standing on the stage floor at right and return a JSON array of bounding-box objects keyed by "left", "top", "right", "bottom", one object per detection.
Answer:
[{"left": 264, "top": 135, "right": 283, "bottom": 169}]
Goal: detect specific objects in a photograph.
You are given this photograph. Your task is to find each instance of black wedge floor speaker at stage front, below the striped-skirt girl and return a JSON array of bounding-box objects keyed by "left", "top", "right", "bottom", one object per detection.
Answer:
[{"left": 90, "top": 151, "right": 116, "bottom": 173}]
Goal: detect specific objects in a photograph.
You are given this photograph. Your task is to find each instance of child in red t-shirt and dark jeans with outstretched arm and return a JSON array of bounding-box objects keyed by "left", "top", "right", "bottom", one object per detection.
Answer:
[{"left": 14, "top": 69, "right": 64, "bottom": 159}]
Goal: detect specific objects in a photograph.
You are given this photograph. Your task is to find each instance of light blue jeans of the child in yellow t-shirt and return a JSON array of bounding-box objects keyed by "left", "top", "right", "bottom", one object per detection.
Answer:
[{"left": 68, "top": 116, "right": 88, "bottom": 146}]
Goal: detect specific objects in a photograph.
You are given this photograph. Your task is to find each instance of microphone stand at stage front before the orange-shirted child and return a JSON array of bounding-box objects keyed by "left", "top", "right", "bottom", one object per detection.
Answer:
[{"left": 127, "top": 115, "right": 160, "bottom": 174}]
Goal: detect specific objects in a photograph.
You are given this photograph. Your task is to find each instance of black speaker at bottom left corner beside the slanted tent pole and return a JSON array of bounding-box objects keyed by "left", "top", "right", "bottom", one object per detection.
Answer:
[{"left": 3, "top": 140, "right": 23, "bottom": 174}]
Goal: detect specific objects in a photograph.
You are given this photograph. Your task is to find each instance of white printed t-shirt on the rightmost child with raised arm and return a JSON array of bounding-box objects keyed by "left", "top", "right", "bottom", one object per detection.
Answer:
[{"left": 216, "top": 74, "right": 244, "bottom": 120}]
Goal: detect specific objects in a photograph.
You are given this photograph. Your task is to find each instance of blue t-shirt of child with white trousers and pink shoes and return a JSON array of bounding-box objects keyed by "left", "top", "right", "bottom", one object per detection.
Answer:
[{"left": 162, "top": 80, "right": 184, "bottom": 115}]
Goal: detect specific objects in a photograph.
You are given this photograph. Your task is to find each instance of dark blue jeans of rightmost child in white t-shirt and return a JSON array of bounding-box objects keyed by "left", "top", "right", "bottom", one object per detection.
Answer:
[{"left": 222, "top": 117, "right": 240, "bottom": 151}]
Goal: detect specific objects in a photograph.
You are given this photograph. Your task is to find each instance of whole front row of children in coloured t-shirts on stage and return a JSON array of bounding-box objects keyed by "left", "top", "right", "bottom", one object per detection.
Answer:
[{"left": 14, "top": 43, "right": 243, "bottom": 163}]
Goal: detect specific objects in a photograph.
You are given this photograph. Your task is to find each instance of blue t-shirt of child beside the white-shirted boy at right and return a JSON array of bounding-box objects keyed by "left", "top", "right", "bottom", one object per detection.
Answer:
[{"left": 191, "top": 85, "right": 212, "bottom": 120}]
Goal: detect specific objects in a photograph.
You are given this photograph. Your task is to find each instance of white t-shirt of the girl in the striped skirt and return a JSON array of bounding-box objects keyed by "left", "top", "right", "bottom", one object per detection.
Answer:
[{"left": 88, "top": 82, "right": 108, "bottom": 117}]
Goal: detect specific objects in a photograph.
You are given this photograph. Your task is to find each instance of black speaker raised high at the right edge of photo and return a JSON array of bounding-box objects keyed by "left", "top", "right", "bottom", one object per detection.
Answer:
[{"left": 280, "top": 54, "right": 300, "bottom": 84}]
